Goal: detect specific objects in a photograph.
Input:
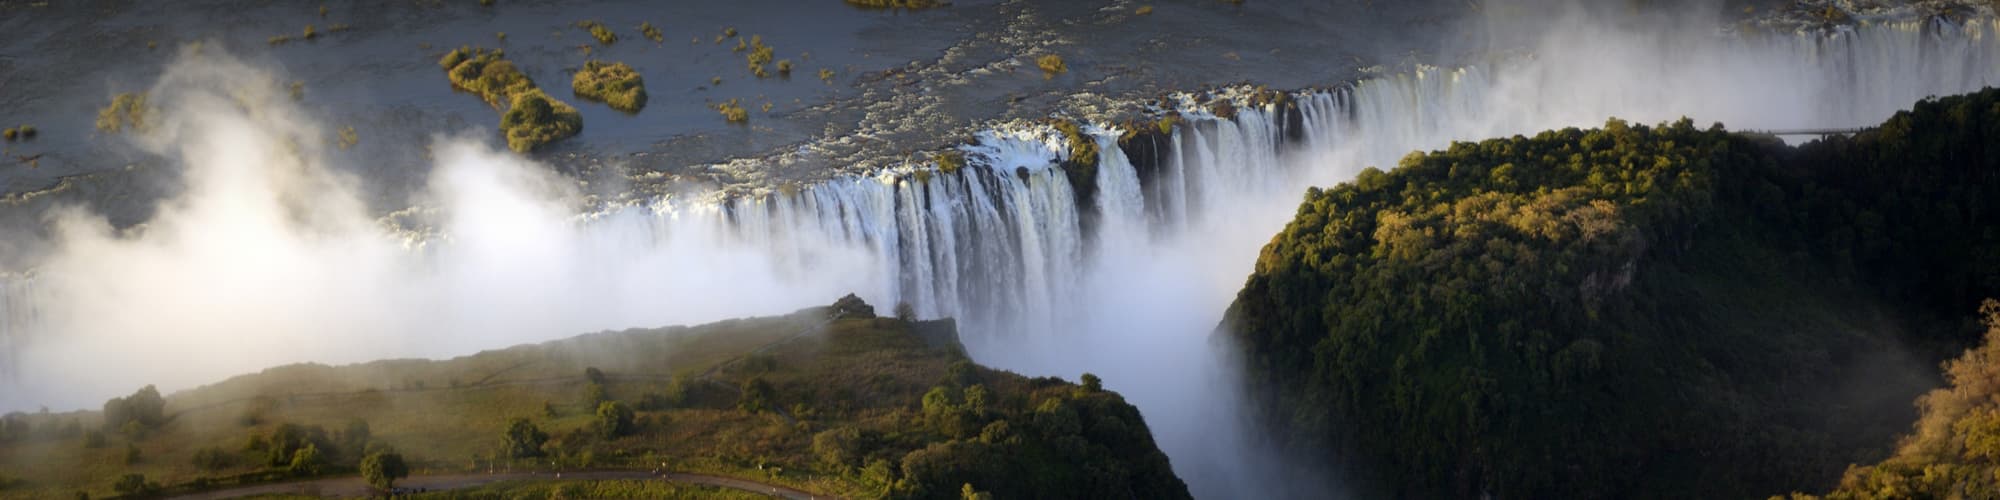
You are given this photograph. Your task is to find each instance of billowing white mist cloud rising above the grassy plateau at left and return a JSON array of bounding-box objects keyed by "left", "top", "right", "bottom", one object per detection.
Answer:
[{"left": 0, "top": 48, "right": 878, "bottom": 410}]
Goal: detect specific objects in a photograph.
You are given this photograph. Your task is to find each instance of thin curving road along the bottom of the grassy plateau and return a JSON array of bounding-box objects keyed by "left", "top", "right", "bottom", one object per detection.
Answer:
[{"left": 174, "top": 470, "right": 836, "bottom": 500}]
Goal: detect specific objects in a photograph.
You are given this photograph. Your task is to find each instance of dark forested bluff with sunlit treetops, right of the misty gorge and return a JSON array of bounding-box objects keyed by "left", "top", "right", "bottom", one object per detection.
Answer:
[{"left": 1224, "top": 90, "right": 2000, "bottom": 498}]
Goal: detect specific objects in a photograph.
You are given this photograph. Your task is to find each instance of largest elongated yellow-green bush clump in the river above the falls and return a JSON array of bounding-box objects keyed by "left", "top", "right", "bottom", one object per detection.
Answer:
[{"left": 438, "top": 48, "right": 584, "bottom": 152}]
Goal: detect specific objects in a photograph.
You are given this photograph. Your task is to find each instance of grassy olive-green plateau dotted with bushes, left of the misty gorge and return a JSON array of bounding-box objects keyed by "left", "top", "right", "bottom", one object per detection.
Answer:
[{"left": 0, "top": 298, "right": 1186, "bottom": 498}]
